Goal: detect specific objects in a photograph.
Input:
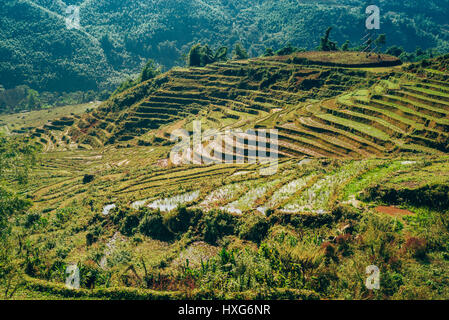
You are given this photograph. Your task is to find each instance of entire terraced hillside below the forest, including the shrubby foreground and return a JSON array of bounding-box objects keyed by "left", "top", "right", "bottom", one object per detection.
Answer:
[{"left": 5, "top": 53, "right": 449, "bottom": 299}]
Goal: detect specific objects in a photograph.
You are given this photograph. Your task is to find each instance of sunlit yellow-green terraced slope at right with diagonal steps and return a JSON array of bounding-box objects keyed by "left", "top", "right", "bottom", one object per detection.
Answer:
[{"left": 276, "top": 74, "right": 449, "bottom": 158}]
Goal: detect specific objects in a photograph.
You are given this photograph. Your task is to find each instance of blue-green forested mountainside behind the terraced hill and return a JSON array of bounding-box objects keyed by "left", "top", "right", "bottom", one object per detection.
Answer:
[{"left": 0, "top": 0, "right": 449, "bottom": 108}]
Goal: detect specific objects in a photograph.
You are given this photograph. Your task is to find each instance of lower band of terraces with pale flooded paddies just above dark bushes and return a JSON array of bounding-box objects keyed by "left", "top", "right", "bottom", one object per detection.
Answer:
[{"left": 31, "top": 147, "right": 438, "bottom": 221}]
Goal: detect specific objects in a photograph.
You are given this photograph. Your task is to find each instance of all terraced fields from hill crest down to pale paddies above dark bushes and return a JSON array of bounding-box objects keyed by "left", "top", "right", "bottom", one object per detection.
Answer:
[{"left": 23, "top": 57, "right": 449, "bottom": 220}]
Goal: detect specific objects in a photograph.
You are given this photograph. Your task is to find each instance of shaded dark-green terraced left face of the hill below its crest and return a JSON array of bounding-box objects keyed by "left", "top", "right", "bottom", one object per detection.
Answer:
[{"left": 29, "top": 53, "right": 400, "bottom": 149}]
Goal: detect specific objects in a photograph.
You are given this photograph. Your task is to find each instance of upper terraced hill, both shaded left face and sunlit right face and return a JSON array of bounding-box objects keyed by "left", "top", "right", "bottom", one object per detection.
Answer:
[{"left": 30, "top": 52, "right": 449, "bottom": 158}]
